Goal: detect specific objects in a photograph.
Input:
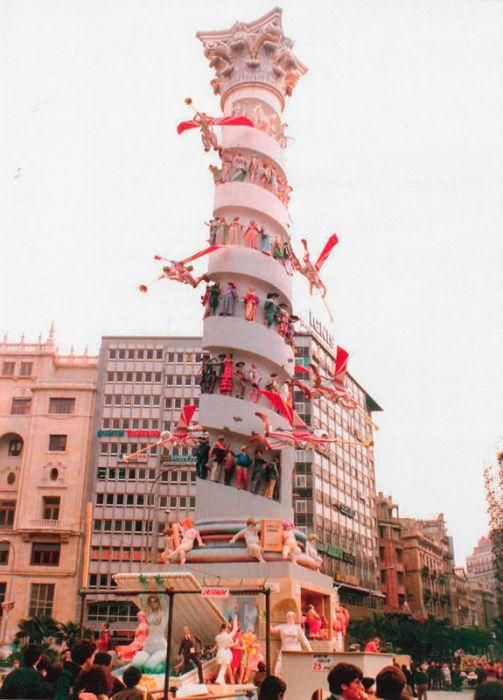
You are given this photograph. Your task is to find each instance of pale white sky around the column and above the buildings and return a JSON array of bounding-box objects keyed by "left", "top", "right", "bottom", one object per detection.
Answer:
[{"left": 0, "top": 0, "right": 503, "bottom": 564}]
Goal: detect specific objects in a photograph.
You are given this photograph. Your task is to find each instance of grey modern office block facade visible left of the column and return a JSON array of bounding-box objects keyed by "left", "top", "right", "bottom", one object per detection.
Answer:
[{"left": 85, "top": 337, "right": 201, "bottom": 629}]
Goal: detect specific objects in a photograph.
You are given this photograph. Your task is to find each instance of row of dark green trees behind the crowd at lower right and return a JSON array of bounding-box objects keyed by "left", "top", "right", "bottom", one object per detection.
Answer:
[{"left": 349, "top": 613, "right": 493, "bottom": 662}]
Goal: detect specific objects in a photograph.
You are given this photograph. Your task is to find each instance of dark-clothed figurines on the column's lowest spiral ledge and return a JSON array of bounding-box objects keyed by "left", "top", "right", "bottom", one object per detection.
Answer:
[{"left": 194, "top": 434, "right": 281, "bottom": 498}]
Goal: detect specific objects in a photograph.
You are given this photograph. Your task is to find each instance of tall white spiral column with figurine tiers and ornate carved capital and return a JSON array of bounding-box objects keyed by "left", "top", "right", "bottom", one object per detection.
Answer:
[{"left": 187, "top": 9, "right": 307, "bottom": 563}]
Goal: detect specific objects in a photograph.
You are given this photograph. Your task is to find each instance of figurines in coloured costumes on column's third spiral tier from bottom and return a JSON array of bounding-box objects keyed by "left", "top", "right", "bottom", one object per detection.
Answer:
[{"left": 201, "top": 281, "right": 299, "bottom": 347}]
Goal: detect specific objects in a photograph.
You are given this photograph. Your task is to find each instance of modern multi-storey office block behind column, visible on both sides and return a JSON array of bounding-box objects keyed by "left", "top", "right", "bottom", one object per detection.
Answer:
[{"left": 86, "top": 324, "right": 382, "bottom": 630}]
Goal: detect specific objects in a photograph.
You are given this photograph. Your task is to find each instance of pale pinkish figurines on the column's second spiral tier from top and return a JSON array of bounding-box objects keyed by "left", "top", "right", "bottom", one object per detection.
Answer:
[{"left": 209, "top": 150, "right": 293, "bottom": 207}]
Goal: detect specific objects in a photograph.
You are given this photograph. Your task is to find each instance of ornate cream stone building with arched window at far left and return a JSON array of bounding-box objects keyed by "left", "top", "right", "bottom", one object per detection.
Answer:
[{"left": 0, "top": 329, "right": 98, "bottom": 639}]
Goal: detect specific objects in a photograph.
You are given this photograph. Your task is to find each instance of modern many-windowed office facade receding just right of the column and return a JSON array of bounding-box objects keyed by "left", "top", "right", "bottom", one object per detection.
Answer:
[{"left": 294, "top": 316, "right": 383, "bottom": 618}]
